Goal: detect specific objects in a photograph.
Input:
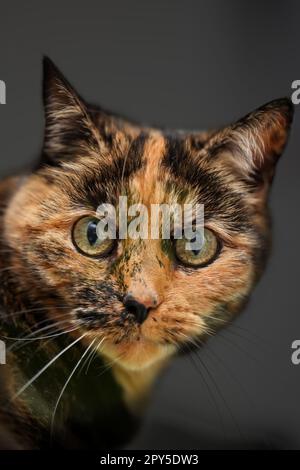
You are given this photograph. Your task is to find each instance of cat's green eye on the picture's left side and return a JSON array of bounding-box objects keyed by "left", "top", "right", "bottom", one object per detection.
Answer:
[{"left": 72, "top": 217, "right": 115, "bottom": 258}]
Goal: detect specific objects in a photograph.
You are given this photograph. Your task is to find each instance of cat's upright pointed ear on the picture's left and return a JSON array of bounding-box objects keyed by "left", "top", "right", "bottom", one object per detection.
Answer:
[{"left": 43, "top": 57, "right": 100, "bottom": 165}]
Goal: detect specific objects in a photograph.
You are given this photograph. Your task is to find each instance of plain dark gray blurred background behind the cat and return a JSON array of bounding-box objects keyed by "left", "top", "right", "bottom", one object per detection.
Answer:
[{"left": 0, "top": 0, "right": 300, "bottom": 449}]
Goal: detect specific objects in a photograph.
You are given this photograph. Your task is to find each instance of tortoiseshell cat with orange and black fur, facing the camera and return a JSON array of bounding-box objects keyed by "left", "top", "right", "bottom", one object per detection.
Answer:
[{"left": 0, "top": 58, "right": 293, "bottom": 449}]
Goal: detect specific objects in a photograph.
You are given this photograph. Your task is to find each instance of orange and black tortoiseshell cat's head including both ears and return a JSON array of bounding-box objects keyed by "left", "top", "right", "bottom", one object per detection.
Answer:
[{"left": 5, "top": 61, "right": 292, "bottom": 369}]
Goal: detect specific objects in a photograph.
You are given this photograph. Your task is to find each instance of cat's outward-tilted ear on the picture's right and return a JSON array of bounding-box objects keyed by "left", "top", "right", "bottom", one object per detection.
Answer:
[{"left": 207, "top": 98, "right": 294, "bottom": 186}]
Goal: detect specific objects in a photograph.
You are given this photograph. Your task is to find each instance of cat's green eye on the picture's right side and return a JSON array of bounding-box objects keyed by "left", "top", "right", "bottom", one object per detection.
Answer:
[{"left": 175, "top": 228, "right": 219, "bottom": 268}]
